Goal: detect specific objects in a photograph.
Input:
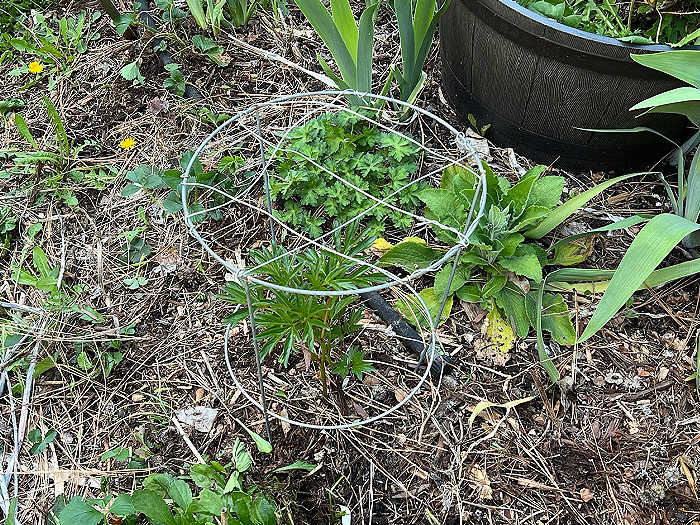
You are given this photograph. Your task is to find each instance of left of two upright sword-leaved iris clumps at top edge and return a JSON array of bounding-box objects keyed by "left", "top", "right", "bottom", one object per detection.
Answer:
[{"left": 295, "top": 0, "right": 380, "bottom": 105}]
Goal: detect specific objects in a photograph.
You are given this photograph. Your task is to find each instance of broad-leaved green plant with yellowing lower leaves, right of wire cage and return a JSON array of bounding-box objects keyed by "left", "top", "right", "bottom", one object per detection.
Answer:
[{"left": 379, "top": 165, "right": 576, "bottom": 344}]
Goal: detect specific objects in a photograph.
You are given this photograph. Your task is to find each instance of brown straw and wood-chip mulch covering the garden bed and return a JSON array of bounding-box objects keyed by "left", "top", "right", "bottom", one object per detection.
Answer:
[{"left": 0, "top": 4, "right": 700, "bottom": 525}]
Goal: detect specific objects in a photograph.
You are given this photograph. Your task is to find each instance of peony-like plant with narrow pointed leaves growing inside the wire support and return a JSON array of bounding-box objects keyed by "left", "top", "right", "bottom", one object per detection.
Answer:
[{"left": 221, "top": 223, "right": 383, "bottom": 396}]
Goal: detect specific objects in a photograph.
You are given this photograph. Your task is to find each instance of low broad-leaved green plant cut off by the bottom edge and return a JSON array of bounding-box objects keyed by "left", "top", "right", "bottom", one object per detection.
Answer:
[{"left": 59, "top": 440, "right": 277, "bottom": 525}]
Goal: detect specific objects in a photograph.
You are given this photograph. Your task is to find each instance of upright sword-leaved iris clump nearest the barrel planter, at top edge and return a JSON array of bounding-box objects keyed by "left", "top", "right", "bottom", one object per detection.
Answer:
[{"left": 393, "top": 0, "right": 451, "bottom": 102}]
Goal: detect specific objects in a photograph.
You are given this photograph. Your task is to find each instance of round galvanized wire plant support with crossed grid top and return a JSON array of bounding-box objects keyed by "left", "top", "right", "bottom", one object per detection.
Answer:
[{"left": 180, "top": 90, "right": 486, "bottom": 434}]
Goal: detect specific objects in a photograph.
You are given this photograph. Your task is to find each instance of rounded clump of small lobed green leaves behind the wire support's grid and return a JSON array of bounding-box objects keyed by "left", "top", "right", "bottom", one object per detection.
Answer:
[{"left": 270, "top": 113, "right": 427, "bottom": 237}]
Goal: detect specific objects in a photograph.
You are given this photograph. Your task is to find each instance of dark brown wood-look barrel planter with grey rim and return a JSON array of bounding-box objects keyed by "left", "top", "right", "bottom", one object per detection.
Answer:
[{"left": 440, "top": 0, "right": 700, "bottom": 169}]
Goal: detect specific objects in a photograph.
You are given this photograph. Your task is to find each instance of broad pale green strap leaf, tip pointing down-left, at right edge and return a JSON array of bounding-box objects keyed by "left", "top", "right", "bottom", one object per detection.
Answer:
[{"left": 579, "top": 213, "right": 700, "bottom": 343}]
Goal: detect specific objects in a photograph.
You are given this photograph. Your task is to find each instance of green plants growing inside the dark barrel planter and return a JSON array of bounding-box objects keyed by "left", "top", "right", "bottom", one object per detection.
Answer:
[{"left": 518, "top": 0, "right": 700, "bottom": 46}]
